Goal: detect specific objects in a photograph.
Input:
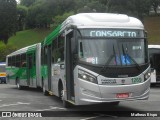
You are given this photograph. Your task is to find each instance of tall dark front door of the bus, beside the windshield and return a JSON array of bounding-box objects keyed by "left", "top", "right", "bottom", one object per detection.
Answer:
[{"left": 65, "top": 31, "right": 75, "bottom": 101}]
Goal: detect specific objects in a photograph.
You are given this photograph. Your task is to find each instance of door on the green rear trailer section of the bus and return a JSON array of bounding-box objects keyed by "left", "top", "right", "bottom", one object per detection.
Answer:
[{"left": 27, "top": 53, "right": 35, "bottom": 86}]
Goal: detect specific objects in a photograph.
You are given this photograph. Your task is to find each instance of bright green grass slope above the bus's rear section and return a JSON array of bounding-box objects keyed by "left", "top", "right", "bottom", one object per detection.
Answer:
[{"left": 8, "top": 29, "right": 52, "bottom": 49}]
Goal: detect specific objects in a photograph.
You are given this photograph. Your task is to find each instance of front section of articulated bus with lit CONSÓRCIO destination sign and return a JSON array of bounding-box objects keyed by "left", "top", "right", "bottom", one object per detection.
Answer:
[{"left": 41, "top": 13, "right": 150, "bottom": 107}]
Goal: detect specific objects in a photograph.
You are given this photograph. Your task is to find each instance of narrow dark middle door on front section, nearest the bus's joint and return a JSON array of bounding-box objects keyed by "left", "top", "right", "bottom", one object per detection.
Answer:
[{"left": 47, "top": 45, "right": 52, "bottom": 91}]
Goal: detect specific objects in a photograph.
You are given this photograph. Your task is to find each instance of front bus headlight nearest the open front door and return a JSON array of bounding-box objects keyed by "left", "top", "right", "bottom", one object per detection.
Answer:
[{"left": 78, "top": 69, "right": 98, "bottom": 84}]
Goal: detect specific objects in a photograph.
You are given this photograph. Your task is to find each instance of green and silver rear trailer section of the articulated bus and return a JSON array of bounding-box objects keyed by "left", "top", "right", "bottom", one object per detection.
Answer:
[{"left": 6, "top": 43, "right": 42, "bottom": 89}]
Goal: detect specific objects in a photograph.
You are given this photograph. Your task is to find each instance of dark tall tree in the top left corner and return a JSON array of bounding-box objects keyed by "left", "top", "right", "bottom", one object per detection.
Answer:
[{"left": 0, "top": 0, "right": 17, "bottom": 44}]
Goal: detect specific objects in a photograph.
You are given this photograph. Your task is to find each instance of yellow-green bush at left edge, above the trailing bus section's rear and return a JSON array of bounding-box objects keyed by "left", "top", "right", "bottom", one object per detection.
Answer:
[{"left": 0, "top": 42, "right": 17, "bottom": 62}]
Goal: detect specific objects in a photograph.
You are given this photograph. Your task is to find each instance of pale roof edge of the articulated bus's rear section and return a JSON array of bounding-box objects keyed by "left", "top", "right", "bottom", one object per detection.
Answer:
[{"left": 7, "top": 43, "right": 40, "bottom": 57}]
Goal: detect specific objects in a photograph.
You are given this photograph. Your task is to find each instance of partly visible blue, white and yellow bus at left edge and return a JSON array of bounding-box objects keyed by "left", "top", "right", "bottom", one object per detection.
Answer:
[{"left": 0, "top": 62, "right": 7, "bottom": 83}]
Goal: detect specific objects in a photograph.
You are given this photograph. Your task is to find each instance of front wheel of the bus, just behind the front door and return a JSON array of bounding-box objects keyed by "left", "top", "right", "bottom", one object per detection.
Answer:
[{"left": 59, "top": 85, "right": 70, "bottom": 108}]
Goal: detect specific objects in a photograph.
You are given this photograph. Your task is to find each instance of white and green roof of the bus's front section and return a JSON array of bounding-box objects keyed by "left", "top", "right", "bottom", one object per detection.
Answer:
[{"left": 42, "top": 13, "right": 144, "bottom": 46}]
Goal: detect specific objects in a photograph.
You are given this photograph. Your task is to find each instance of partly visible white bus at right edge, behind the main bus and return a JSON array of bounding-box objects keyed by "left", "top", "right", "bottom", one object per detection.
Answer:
[{"left": 148, "top": 45, "right": 160, "bottom": 85}]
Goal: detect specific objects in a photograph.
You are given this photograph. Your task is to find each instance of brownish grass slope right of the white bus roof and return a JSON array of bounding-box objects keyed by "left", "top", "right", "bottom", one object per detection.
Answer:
[{"left": 144, "top": 16, "right": 160, "bottom": 44}]
